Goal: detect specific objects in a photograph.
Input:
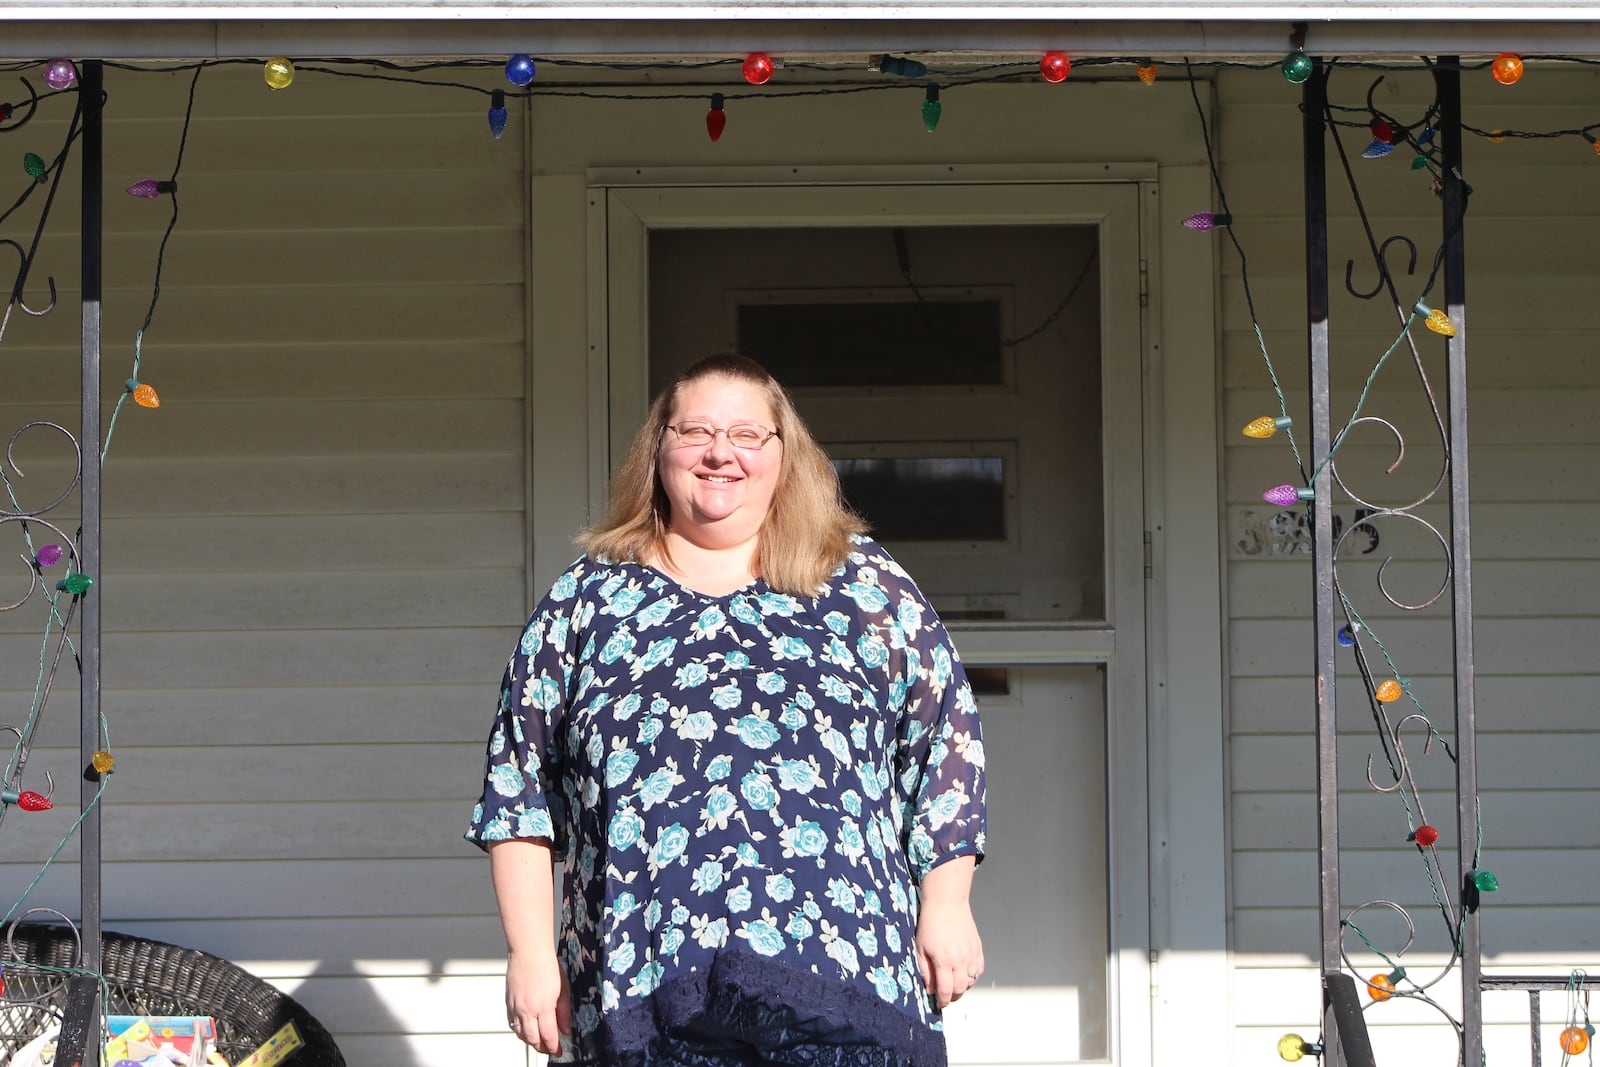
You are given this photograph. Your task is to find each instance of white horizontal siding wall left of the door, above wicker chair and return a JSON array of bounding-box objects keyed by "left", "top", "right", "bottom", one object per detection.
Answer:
[{"left": 0, "top": 64, "right": 528, "bottom": 1064}]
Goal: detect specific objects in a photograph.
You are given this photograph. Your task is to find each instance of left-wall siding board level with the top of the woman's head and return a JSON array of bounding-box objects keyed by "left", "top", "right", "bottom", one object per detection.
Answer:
[{"left": 5, "top": 347, "right": 526, "bottom": 404}]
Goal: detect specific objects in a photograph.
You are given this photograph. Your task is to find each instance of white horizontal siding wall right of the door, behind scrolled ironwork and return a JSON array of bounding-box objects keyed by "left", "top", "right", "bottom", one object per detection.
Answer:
[{"left": 1218, "top": 66, "right": 1600, "bottom": 1064}]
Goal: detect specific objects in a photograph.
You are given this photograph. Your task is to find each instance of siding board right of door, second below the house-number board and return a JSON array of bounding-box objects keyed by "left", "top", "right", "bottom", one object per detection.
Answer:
[{"left": 1229, "top": 617, "right": 1600, "bottom": 675}]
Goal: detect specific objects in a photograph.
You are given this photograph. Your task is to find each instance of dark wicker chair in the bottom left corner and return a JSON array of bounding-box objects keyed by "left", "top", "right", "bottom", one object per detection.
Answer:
[{"left": 0, "top": 923, "right": 344, "bottom": 1067}]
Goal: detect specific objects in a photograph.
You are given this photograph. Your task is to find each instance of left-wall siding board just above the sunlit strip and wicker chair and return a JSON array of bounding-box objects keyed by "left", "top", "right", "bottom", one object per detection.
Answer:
[{"left": 0, "top": 848, "right": 492, "bottom": 921}]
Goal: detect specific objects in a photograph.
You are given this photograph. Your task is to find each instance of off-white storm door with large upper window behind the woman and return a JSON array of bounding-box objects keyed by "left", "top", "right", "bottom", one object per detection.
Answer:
[{"left": 605, "top": 184, "right": 1149, "bottom": 1065}]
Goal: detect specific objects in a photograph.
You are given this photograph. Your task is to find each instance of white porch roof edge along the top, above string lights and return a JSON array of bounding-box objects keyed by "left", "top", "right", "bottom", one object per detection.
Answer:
[{"left": 0, "top": 8, "right": 1600, "bottom": 59}]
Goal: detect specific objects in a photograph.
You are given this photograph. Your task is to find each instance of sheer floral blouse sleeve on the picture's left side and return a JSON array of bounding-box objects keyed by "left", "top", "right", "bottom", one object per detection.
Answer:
[{"left": 466, "top": 560, "right": 590, "bottom": 856}]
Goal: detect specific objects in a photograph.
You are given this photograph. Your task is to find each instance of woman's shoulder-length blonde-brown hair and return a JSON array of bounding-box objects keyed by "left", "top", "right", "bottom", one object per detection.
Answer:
[{"left": 578, "top": 354, "right": 867, "bottom": 597}]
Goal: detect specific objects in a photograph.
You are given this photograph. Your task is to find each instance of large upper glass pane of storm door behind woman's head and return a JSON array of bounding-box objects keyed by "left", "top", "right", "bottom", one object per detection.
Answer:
[{"left": 648, "top": 226, "right": 1106, "bottom": 622}]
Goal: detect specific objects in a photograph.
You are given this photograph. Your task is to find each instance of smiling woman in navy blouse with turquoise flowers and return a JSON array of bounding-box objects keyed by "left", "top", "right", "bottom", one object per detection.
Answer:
[{"left": 467, "top": 355, "right": 986, "bottom": 1067}]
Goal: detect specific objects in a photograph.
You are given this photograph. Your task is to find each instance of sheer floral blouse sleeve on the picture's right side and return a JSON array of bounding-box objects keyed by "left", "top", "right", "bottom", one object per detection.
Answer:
[{"left": 840, "top": 542, "right": 986, "bottom": 883}]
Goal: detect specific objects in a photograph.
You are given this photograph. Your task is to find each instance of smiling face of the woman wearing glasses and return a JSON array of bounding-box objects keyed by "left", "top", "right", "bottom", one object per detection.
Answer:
[{"left": 656, "top": 378, "right": 784, "bottom": 549}]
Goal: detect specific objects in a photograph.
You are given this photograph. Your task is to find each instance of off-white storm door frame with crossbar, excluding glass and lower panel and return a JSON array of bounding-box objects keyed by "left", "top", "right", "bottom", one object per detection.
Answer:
[{"left": 589, "top": 166, "right": 1154, "bottom": 1064}]
